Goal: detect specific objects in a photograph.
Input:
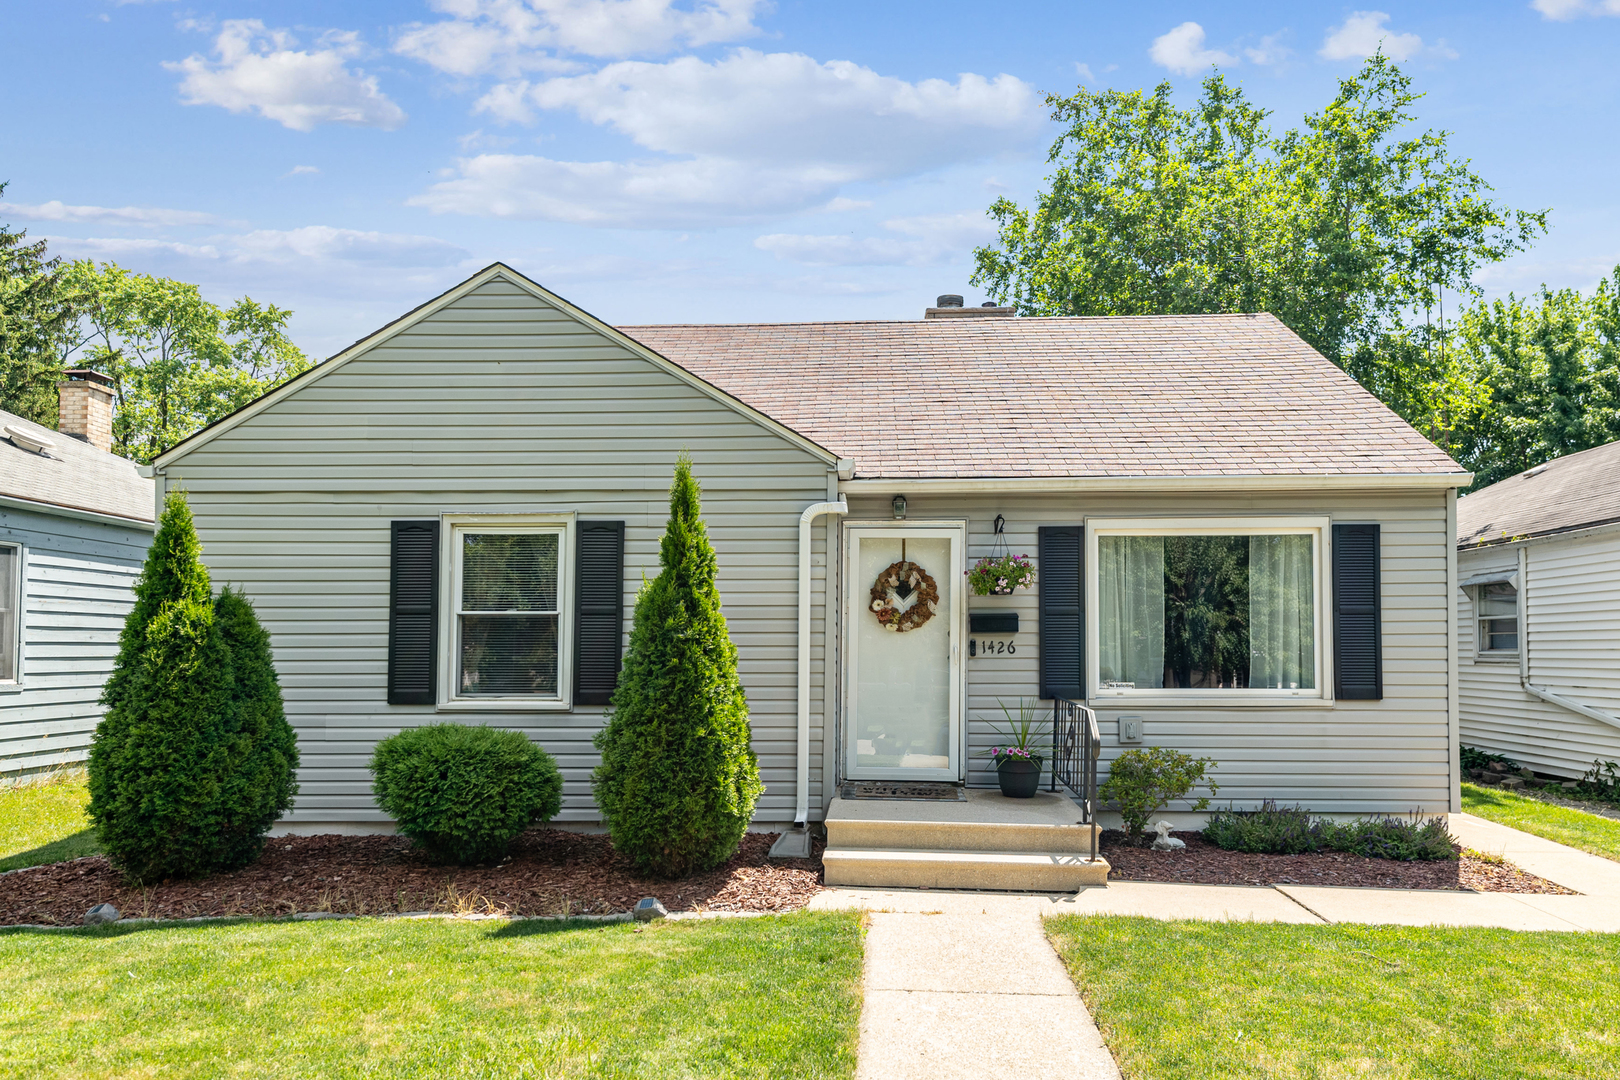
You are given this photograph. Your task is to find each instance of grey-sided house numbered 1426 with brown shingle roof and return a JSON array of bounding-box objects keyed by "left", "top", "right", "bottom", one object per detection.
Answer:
[{"left": 156, "top": 264, "right": 1468, "bottom": 832}]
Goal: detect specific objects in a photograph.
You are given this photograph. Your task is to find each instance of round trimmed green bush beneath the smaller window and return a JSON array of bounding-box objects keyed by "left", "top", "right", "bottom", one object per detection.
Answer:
[{"left": 371, "top": 724, "right": 562, "bottom": 865}]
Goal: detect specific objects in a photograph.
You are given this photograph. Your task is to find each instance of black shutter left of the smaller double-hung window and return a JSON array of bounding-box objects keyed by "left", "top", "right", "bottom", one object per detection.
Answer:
[{"left": 389, "top": 521, "right": 439, "bottom": 704}]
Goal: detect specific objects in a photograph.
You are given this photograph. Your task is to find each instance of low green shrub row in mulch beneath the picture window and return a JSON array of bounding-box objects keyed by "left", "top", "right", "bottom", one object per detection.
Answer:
[{"left": 1204, "top": 800, "right": 1456, "bottom": 861}]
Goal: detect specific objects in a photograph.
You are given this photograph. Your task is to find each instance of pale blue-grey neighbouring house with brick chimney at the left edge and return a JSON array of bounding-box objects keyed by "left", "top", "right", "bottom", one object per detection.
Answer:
[{"left": 0, "top": 371, "right": 152, "bottom": 779}]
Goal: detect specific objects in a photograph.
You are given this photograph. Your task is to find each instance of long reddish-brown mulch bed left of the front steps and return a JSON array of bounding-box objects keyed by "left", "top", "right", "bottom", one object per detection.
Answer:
[{"left": 0, "top": 829, "right": 823, "bottom": 926}]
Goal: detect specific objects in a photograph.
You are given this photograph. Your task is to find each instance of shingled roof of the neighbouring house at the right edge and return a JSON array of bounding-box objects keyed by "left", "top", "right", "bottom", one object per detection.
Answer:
[{"left": 1456, "top": 442, "right": 1620, "bottom": 547}]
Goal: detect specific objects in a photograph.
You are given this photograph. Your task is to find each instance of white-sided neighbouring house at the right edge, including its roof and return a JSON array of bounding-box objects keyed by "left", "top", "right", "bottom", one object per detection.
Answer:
[{"left": 1456, "top": 442, "right": 1620, "bottom": 777}]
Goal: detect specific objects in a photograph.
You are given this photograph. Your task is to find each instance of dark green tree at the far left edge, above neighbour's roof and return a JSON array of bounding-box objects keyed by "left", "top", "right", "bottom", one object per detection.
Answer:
[{"left": 0, "top": 183, "right": 76, "bottom": 427}]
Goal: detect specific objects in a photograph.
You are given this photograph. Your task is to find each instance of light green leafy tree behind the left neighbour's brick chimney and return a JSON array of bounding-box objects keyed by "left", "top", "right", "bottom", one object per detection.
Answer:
[{"left": 60, "top": 259, "right": 309, "bottom": 461}]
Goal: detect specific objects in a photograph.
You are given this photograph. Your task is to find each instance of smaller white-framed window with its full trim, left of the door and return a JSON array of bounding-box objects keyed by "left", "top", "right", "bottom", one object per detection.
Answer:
[{"left": 439, "top": 515, "right": 573, "bottom": 709}]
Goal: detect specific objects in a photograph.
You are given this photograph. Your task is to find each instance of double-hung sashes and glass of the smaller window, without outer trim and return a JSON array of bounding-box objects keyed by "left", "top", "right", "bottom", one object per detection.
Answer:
[{"left": 454, "top": 525, "right": 565, "bottom": 698}]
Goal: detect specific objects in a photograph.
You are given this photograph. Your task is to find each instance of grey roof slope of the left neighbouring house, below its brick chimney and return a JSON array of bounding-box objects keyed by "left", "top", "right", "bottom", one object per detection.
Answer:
[{"left": 0, "top": 411, "right": 152, "bottom": 528}]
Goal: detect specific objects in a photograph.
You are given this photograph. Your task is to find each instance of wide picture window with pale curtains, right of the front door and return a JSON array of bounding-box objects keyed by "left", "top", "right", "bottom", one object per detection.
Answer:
[{"left": 1095, "top": 529, "right": 1320, "bottom": 696}]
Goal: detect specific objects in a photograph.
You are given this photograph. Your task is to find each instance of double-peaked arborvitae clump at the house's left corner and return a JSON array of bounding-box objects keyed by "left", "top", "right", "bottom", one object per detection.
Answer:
[{"left": 89, "top": 492, "right": 298, "bottom": 881}]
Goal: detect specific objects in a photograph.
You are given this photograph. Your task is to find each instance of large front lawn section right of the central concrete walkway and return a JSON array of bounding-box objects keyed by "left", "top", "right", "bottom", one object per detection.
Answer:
[{"left": 1047, "top": 915, "right": 1620, "bottom": 1080}]
